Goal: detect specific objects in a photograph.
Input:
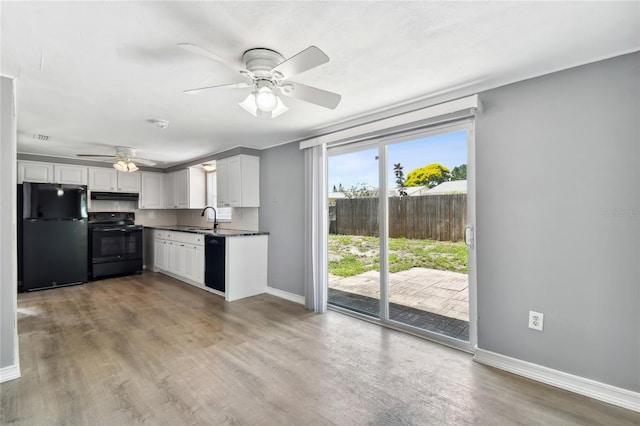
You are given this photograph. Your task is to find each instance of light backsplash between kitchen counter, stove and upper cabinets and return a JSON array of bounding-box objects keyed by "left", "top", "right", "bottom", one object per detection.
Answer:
[{"left": 89, "top": 200, "right": 258, "bottom": 231}]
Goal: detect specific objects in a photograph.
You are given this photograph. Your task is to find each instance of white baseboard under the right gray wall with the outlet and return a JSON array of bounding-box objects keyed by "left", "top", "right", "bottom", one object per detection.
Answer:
[{"left": 473, "top": 349, "right": 640, "bottom": 412}]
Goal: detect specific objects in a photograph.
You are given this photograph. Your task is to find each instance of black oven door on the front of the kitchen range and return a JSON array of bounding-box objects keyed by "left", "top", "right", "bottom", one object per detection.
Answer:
[{"left": 90, "top": 227, "right": 142, "bottom": 264}]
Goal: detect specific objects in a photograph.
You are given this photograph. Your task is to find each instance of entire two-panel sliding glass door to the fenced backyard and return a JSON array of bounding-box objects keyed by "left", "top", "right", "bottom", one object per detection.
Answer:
[{"left": 328, "top": 121, "right": 473, "bottom": 346}]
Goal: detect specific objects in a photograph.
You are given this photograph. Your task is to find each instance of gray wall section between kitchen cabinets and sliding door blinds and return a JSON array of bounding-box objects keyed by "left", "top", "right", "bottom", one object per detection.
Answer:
[{"left": 260, "top": 143, "right": 304, "bottom": 296}]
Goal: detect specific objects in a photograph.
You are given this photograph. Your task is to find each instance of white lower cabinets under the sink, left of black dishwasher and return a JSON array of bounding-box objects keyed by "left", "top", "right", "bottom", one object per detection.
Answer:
[{"left": 153, "top": 230, "right": 204, "bottom": 287}]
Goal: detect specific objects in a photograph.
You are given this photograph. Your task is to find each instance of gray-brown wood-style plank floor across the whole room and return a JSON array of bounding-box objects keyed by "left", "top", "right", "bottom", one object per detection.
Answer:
[{"left": 0, "top": 273, "right": 640, "bottom": 425}]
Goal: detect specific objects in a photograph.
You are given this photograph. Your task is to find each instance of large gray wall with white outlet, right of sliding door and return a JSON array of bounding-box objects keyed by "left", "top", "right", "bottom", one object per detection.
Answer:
[{"left": 476, "top": 53, "right": 640, "bottom": 391}]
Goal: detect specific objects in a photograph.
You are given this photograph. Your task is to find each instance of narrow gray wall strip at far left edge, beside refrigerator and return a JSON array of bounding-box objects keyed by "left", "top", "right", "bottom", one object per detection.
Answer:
[{"left": 0, "top": 77, "right": 17, "bottom": 368}]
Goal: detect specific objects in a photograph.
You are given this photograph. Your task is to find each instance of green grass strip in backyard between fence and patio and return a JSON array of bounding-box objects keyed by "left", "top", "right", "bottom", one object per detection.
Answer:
[{"left": 329, "top": 235, "right": 468, "bottom": 277}]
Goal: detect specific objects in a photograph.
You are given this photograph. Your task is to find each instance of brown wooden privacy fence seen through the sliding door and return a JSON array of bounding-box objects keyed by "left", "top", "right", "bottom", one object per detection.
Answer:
[{"left": 329, "top": 194, "right": 467, "bottom": 241}]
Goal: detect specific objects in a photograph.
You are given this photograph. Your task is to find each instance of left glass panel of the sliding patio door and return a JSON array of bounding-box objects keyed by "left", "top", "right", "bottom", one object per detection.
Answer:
[{"left": 328, "top": 146, "right": 380, "bottom": 319}]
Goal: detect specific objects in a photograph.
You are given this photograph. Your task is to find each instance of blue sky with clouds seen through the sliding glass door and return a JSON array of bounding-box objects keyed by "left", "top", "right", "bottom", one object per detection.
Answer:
[{"left": 328, "top": 130, "right": 467, "bottom": 191}]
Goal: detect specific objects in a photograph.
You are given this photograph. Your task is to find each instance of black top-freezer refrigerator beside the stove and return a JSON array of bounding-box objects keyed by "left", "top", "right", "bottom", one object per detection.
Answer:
[{"left": 18, "top": 183, "right": 88, "bottom": 291}]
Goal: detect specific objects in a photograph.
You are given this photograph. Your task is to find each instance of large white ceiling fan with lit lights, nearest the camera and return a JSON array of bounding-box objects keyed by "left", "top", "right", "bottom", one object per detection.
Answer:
[{"left": 178, "top": 43, "right": 342, "bottom": 118}]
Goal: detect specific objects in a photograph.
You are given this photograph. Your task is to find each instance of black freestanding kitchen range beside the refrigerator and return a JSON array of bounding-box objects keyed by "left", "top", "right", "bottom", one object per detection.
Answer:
[{"left": 89, "top": 212, "right": 143, "bottom": 280}]
